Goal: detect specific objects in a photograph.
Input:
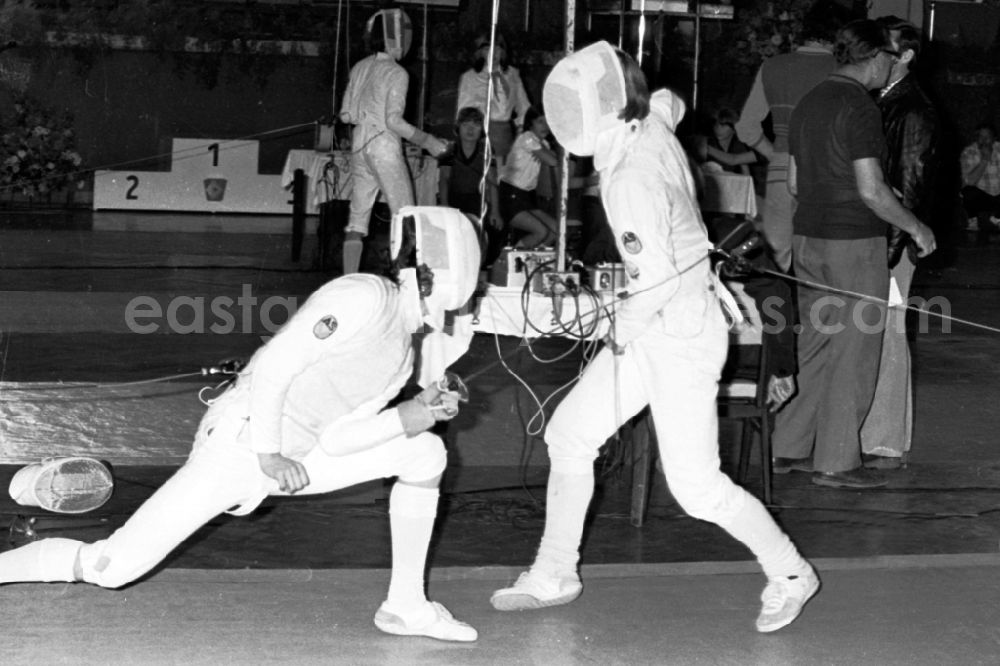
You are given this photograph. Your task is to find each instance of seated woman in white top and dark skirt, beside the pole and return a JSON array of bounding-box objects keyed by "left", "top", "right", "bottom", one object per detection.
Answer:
[{"left": 500, "top": 107, "right": 559, "bottom": 249}]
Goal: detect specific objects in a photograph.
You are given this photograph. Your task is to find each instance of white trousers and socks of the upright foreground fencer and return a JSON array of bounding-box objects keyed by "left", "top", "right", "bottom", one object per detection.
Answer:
[{"left": 539, "top": 299, "right": 806, "bottom": 577}]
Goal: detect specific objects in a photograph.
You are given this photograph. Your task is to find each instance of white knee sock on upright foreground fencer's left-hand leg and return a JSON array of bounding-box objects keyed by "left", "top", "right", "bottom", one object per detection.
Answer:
[{"left": 532, "top": 459, "right": 594, "bottom": 574}]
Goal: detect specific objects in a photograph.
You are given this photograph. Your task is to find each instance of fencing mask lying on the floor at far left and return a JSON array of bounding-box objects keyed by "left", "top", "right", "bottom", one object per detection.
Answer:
[{"left": 9, "top": 457, "right": 114, "bottom": 513}]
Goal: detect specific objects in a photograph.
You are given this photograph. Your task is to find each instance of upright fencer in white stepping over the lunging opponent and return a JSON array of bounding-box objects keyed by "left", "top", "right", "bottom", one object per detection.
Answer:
[{"left": 491, "top": 42, "right": 819, "bottom": 631}]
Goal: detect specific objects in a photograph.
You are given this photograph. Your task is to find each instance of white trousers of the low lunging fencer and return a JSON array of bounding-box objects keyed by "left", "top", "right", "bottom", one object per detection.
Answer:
[{"left": 68, "top": 432, "right": 447, "bottom": 588}]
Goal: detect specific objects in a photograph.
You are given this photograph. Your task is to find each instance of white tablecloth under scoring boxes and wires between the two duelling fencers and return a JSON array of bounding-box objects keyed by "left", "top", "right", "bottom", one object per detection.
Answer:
[{"left": 472, "top": 285, "right": 614, "bottom": 340}]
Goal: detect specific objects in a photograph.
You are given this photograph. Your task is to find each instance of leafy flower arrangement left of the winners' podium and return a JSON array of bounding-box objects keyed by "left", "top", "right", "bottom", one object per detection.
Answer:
[{"left": 0, "top": 95, "right": 83, "bottom": 197}]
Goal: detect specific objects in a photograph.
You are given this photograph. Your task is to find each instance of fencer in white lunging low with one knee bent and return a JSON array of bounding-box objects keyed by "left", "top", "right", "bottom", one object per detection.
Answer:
[{"left": 0, "top": 207, "right": 479, "bottom": 641}]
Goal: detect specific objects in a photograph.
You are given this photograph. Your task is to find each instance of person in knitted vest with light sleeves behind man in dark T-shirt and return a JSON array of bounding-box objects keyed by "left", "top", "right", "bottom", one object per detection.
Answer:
[{"left": 736, "top": 0, "right": 847, "bottom": 271}]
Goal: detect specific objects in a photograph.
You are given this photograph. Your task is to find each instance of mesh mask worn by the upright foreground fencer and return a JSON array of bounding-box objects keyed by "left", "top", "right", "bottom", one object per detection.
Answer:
[{"left": 542, "top": 41, "right": 626, "bottom": 155}]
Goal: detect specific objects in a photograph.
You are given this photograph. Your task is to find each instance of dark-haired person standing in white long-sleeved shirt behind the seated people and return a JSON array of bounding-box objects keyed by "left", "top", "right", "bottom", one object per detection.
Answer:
[{"left": 457, "top": 34, "right": 531, "bottom": 166}]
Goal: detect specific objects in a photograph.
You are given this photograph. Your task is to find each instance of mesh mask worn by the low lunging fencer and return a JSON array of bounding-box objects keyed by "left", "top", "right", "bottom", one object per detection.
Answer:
[{"left": 389, "top": 206, "right": 479, "bottom": 331}]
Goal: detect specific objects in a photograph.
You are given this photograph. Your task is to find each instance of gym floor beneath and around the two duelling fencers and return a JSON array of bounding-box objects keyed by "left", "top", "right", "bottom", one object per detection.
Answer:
[{"left": 0, "top": 215, "right": 1000, "bottom": 664}]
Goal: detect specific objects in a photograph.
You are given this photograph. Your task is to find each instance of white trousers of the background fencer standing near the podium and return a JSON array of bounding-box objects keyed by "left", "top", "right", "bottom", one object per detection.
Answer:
[{"left": 345, "top": 133, "right": 413, "bottom": 236}]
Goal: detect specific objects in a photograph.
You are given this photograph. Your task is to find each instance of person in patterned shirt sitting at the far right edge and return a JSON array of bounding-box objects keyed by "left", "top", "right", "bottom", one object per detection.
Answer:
[{"left": 962, "top": 123, "right": 1000, "bottom": 245}]
